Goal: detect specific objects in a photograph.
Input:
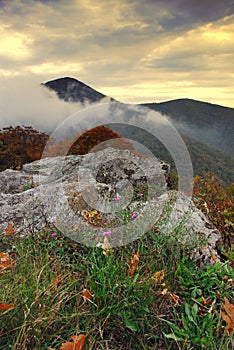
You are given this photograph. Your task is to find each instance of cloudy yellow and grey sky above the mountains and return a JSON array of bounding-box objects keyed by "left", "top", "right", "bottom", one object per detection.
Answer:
[{"left": 0, "top": 0, "right": 234, "bottom": 115}]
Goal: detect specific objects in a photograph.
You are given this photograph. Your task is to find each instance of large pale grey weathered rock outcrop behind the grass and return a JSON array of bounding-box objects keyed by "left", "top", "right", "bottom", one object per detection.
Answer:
[{"left": 0, "top": 148, "right": 220, "bottom": 264}]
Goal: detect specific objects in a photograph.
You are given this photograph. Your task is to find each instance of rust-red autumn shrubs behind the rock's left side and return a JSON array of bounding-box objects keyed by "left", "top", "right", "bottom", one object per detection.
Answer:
[{"left": 0, "top": 125, "right": 134, "bottom": 171}]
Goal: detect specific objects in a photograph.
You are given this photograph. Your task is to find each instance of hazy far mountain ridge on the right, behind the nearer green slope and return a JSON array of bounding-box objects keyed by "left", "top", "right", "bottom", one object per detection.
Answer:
[{"left": 142, "top": 99, "right": 234, "bottom": 156}]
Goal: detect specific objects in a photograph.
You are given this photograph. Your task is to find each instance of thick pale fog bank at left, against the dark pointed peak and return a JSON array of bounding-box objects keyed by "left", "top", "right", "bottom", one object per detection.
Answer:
[{"left": 0, "top": 76, "right": 84, "bottom": 131}]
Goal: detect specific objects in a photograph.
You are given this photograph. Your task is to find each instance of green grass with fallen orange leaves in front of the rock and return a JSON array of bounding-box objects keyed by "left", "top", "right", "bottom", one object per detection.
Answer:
[{"left": 0, "top": 230, "right": 233, "bottom": 350}]
